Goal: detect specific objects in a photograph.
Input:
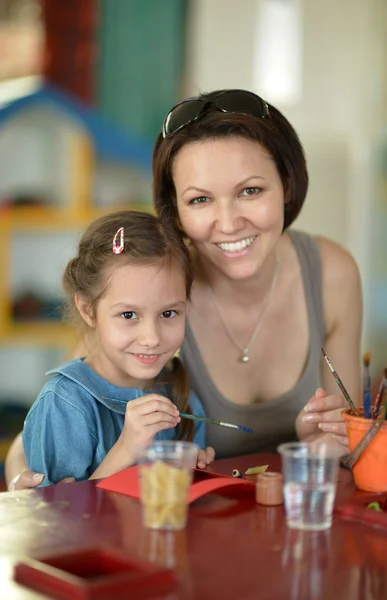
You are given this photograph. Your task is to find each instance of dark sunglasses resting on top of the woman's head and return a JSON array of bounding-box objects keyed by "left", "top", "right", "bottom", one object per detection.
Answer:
[{"left": 163, "top": 90, "right": 270, "bottom": 138}]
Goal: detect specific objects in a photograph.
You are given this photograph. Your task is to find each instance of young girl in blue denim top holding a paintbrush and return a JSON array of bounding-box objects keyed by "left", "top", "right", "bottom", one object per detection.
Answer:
[{"left": 23, "top": 211, "right": 214, "bottom": 485}]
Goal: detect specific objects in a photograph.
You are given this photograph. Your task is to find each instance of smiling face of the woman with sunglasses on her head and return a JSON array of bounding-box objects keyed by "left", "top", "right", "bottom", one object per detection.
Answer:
[{"left": 173, "top": 137, "right": 284, "bottom": 280}]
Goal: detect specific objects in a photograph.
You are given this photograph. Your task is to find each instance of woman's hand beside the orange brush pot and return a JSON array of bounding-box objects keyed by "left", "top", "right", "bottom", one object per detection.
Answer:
[{"left": 296, "top": 388, "right": 348, "bottom": 451}]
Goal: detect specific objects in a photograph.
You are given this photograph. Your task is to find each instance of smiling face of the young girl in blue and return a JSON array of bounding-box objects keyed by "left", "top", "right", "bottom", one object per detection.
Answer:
[{"left": 81, "top": 263, "right": 187, "bottom": 388}]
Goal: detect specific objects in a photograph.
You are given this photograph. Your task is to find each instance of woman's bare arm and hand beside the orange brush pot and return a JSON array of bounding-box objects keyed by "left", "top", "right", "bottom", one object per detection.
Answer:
[{"left": 296, "top": 238, "right": 362, "bottom": 444}]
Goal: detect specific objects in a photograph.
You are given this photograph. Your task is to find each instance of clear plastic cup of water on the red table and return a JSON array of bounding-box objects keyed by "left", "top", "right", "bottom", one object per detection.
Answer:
[{"left": 278, "top": 442, "right": 339, "bottom": 531}]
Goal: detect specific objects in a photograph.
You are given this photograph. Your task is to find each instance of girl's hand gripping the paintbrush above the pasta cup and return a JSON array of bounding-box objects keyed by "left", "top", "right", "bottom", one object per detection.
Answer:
[{"left": 119, "top": 394, "right": 180, "bottom": 461}]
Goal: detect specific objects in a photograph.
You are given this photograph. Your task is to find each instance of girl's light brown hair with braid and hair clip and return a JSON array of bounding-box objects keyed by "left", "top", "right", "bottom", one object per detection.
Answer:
[{"left": 63, "top": 210, "right": 194, "bottom": 440}]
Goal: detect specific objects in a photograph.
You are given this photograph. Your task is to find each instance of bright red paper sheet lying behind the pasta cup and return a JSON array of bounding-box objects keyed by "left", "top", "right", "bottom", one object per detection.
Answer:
[{"left": 97, "top": 466, "right": 255, "bottom": 502}]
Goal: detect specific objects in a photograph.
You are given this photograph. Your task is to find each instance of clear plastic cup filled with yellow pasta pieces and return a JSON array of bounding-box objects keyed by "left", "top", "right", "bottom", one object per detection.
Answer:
[{"left": 139, "top": 441, "right": 199, "bottom": 530}]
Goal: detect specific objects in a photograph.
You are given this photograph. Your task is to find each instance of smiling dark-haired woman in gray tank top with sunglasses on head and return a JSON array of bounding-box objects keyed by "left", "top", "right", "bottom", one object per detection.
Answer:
[{"left": 8, "top": 90, "right": 362, "bottom": 487}]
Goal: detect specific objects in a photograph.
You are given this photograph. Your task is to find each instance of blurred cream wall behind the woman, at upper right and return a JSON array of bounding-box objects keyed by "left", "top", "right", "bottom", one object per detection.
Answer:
[{"left": 184, "top": 0, "right": 387, "bottom": 370}]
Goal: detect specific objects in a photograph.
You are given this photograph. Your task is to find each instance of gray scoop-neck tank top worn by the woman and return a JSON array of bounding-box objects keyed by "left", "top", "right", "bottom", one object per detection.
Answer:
[{"left": 180, "top": 231, "right": 325, "bottom": 458}]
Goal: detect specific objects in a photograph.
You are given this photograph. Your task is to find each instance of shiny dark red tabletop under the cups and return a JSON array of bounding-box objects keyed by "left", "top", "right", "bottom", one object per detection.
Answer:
[{"left": 0, "top": 454, "right": 387, "bottom": 600}]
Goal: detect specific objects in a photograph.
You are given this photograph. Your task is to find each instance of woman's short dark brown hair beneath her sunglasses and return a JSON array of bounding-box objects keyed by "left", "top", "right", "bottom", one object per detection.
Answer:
[{"left": 153, "top": 90, "right": 308, "bottom": 229}]
